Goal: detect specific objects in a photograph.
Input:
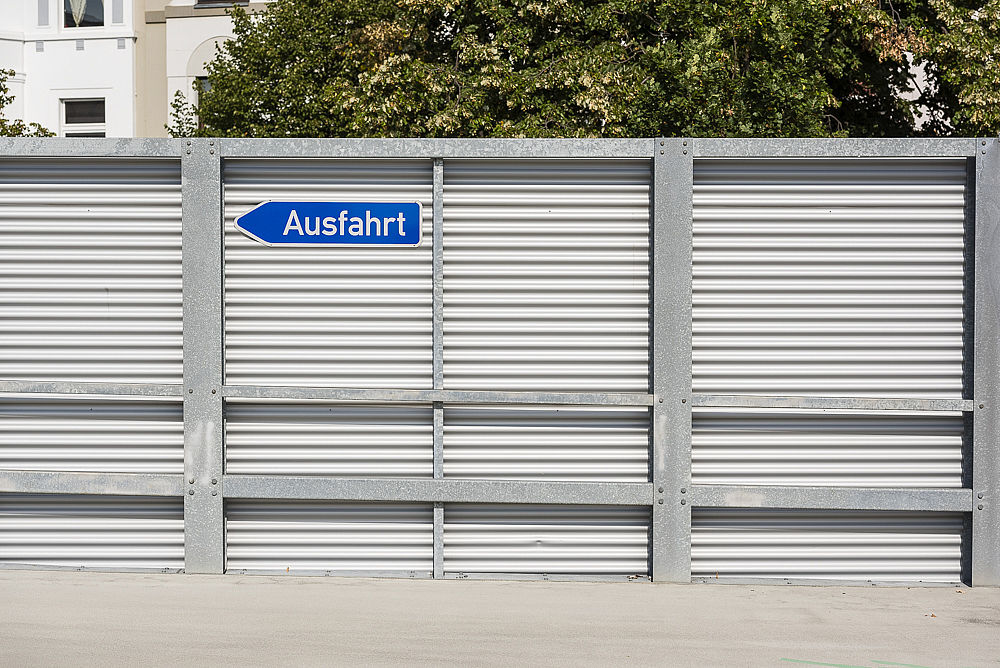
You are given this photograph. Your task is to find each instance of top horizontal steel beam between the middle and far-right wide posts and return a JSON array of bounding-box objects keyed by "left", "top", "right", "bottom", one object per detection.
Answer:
[{"left": 692, "top": 137, "right": 977, "bottom": 158}]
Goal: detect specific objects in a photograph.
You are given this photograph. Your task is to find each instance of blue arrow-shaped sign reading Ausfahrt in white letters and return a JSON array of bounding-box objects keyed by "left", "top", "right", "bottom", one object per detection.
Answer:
[{"left": 236, "top": 201, "right": 421, "bottom": 247}]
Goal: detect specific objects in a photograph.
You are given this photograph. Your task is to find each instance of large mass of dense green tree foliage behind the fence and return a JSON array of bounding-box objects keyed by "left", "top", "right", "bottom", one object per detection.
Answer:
[{"left": 171, "top": 0, "right": 998, "bottom": 137}]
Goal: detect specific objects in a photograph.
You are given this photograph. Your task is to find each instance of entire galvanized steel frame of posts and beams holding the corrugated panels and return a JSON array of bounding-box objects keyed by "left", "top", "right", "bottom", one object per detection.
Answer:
[{"left": 0, "top": 138, "right": 1000, "bottom": 585}]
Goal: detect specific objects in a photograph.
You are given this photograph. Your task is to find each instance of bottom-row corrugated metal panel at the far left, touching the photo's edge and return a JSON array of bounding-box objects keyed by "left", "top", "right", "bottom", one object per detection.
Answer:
[{"left": 0, "top": 494, "right": 184, "bottom": 569}]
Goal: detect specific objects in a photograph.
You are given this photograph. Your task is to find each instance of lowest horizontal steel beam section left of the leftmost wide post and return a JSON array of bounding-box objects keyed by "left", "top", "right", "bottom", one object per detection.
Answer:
[{"left": 0, "top": 471, "right": 184, "bottom": 498}]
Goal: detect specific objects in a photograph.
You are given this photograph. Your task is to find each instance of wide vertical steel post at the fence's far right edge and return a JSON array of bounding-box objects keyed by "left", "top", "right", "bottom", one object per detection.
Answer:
[{"left": 972, "top": 138, "right": 1000, "bottom": 586}]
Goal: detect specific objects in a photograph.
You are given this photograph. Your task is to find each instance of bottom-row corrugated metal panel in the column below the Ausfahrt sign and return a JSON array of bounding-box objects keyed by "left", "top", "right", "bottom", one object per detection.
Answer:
[{"left": 226, "top": 499, "right": 434, "bottom": 574}]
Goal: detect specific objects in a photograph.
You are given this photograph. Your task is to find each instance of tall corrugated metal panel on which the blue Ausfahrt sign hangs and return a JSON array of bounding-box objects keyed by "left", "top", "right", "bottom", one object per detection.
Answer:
[{"left": 224, "top": 160, "right": 433, "bottom": 389}]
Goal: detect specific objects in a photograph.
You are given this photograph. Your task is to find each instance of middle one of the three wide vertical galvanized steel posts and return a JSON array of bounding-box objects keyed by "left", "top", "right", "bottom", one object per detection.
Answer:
[{"left": 650, "top": 138, "right": 694, "bottom": 582}]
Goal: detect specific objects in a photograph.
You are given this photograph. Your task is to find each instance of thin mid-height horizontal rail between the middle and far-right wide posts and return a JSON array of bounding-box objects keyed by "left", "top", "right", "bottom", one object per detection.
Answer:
[{"left": 691, "top": 394, "right": 975, "bottom": 411}]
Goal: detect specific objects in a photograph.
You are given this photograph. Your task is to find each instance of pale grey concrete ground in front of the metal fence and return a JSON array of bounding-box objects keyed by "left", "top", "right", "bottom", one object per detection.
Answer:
[{"left": 0, "top": 571, "right": 1000, "bottom": 668}]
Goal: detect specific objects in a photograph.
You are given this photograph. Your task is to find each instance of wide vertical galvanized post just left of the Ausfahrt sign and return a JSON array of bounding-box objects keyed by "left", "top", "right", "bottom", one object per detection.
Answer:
[{"left": 181, "top": 139, "right": 225, "bottom": 573}]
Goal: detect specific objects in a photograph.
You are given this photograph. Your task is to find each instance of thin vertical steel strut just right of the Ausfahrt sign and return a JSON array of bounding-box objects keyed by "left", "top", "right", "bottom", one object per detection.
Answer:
[{"left": 432, "top": 158, "right": 444, "bottom": 578}]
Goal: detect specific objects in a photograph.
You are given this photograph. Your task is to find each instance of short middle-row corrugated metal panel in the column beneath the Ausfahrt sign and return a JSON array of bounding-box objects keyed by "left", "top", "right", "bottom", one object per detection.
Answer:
[{"left": 226, "top": 400, "right": 434, "bottom": 478}]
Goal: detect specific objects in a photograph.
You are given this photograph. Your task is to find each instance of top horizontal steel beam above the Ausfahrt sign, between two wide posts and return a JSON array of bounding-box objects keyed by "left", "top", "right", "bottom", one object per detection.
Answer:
[{"left": 219, "top": 138, "right": 653, "bottom": 160}]
